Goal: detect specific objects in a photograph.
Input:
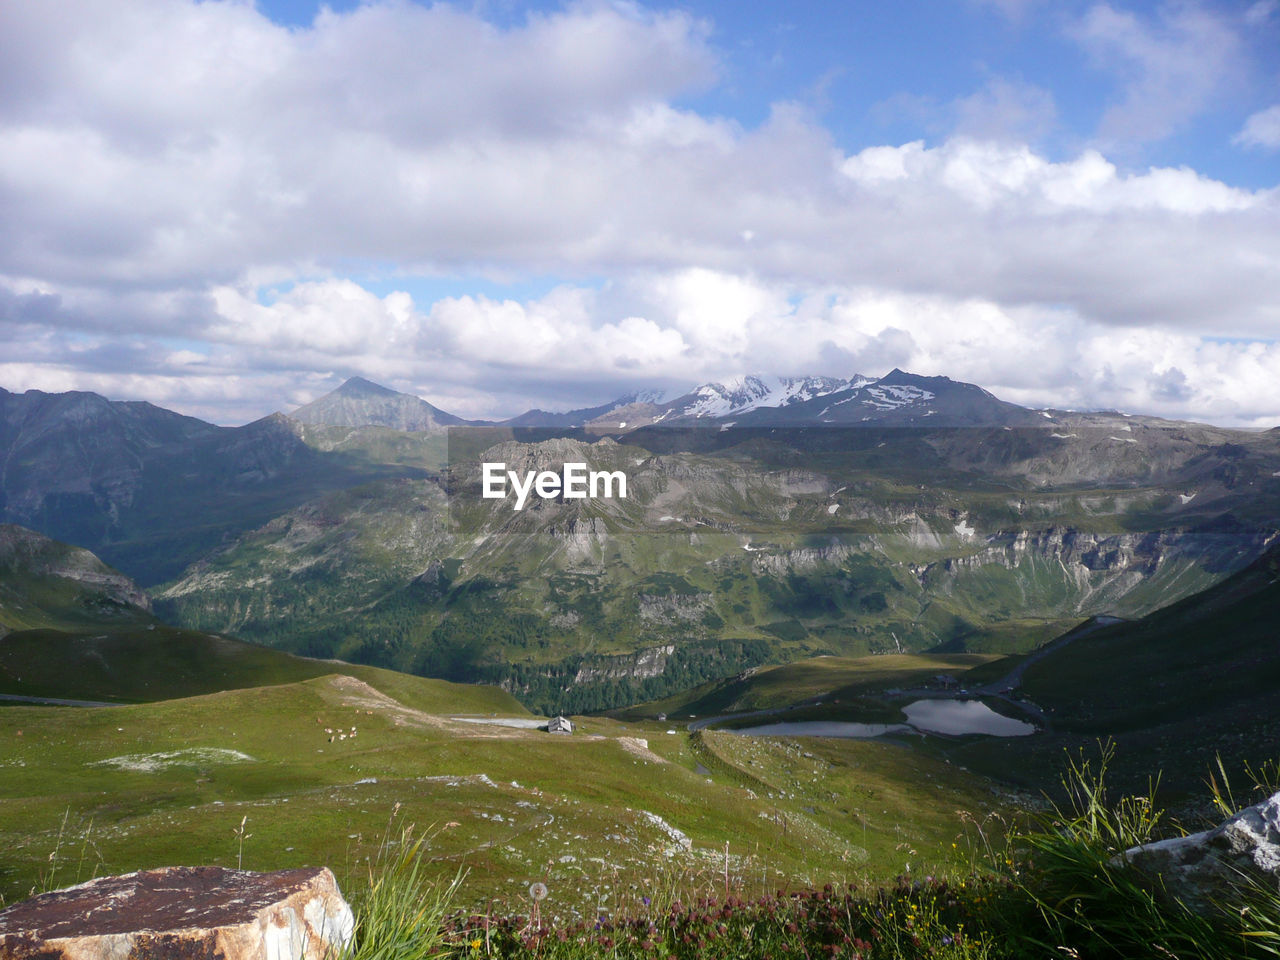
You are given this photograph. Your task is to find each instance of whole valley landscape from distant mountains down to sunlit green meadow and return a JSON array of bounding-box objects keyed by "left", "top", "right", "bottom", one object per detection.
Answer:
[{"left": 0, "top": 371, "right": 1280, "bottom": 920}]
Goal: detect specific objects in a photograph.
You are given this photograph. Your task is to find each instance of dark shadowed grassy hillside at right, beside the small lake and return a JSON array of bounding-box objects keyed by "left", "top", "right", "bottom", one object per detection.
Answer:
[{"left": 960, "top": 549, "right": 1280, "bottom": 796}]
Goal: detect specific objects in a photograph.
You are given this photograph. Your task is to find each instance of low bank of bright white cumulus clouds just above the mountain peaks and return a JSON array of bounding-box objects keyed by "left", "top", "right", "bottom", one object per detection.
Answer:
[{"left": 0, "top": 268, "right": 1280, "bottom": 425}]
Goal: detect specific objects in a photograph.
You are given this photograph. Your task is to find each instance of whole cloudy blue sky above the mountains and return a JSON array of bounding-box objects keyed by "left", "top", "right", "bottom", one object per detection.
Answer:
[{"left": 0, "top": 0, "right": 1280, "bottom": 428}]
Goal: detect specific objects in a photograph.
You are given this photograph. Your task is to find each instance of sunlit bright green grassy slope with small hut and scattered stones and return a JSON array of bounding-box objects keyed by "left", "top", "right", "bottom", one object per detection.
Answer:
[{"left": 0, "top": 675, "right": 1007, "bottom": 916}]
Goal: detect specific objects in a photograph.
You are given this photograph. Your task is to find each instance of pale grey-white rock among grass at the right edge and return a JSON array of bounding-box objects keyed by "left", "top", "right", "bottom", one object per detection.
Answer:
[{"left": 1124, "top": 794, "right": 1280, "bottom": 909}]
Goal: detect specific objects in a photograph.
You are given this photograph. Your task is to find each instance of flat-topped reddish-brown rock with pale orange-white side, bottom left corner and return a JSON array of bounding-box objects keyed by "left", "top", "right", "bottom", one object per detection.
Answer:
[{"left": 0, "top": 867, "right": 355, "bottom": 960}]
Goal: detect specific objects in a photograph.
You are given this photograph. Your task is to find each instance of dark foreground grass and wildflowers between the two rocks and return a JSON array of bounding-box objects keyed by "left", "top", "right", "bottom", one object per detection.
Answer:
[{"left": 335, "top": 746, "right": 1280, "bottom": 960}]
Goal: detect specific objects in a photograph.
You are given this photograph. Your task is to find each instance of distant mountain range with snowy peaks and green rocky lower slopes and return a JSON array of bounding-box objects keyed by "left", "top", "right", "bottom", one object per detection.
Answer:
[{"left": 0, "top": 370, "right": 1280, "bottom": 709}]
